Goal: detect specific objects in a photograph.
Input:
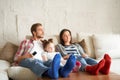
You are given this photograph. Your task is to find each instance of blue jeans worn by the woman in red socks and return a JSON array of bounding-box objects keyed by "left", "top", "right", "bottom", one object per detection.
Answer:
[{"left": 76, "top": 56, "right": 97, "bottom": 71}]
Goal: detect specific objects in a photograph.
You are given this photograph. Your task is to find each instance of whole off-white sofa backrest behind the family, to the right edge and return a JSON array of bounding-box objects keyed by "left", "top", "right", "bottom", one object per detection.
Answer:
[{"left": 20, "top": 33, "right": 120, "bottom": 59}]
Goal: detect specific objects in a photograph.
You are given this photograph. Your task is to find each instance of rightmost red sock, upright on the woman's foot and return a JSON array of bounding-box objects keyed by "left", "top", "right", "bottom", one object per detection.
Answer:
[{"left": 100, "top": 54, "right": 111, "bottom": 74}]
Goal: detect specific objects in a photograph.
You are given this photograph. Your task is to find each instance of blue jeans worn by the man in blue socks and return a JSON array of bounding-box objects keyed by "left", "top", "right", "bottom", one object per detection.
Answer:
[{"left": 19, "top": 58, "right": 52, "bottom": 77}]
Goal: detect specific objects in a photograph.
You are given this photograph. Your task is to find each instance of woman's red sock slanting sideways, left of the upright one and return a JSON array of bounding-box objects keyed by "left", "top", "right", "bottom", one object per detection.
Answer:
[{"left": 86, "top": 59, "right": 105, "bottom": 75}]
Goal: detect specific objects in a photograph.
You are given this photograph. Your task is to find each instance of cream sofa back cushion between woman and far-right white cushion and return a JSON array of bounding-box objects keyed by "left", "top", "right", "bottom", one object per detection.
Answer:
[{"left": 77, "top": 33, "right": 95, "bottom": 58}]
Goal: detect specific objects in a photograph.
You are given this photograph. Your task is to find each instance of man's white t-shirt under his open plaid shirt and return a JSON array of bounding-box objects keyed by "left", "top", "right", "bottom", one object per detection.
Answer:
[{"left": 30, "top": 40, "right": 44, "bottom": 60}]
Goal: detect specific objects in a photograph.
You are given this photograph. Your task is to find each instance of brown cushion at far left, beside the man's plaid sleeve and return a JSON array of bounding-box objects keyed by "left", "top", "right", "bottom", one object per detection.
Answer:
[{"left": 0, "top": 42, "right": 18, "bottom": 63}]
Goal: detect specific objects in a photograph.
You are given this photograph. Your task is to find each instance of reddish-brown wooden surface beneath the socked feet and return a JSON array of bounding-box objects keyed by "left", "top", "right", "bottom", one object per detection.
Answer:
[{"left": 41, "top": 72, "right": 120, "bottom": 80}]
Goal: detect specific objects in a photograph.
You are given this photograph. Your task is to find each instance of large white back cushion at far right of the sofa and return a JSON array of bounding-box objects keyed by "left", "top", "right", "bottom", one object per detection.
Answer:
[{"left": 93, "top": 34, "right": 120, "bottom": 59}]
